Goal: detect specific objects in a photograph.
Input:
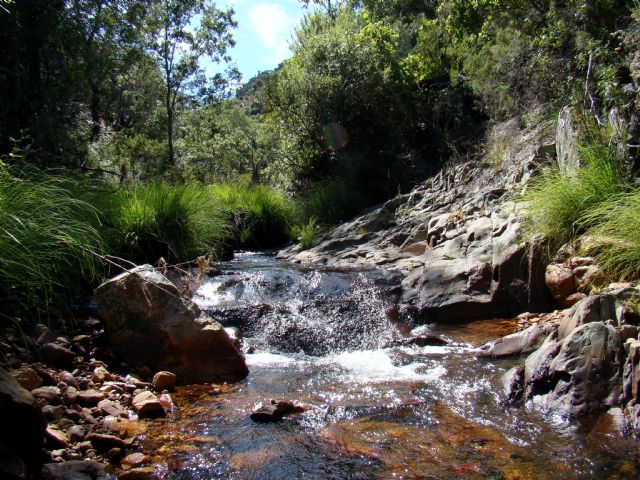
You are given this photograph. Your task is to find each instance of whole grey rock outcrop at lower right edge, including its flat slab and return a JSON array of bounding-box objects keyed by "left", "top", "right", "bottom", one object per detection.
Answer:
[{"left": 500, "top": 288, "right": 640, "bottom": 424}]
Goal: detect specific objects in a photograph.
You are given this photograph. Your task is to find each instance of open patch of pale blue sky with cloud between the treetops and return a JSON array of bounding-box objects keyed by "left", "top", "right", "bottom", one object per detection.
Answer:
[{"left": 216, "top": 0, "right": 305, "bottom": 82}]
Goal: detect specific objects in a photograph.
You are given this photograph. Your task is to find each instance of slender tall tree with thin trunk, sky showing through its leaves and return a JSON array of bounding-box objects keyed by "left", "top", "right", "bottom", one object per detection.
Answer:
[{"left": 147, "top": 0, "right": 237, "bottom": 174}]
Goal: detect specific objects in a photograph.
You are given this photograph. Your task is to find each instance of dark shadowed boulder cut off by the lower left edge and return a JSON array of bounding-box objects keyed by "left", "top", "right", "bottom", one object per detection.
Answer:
[{"left": 0, "top": 368, "right": 47, "bottom": 468}]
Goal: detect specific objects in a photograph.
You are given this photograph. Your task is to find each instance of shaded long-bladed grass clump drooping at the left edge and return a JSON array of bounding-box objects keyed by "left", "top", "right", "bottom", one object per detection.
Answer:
[{"left": 0, "top": 163, "right": 104, "bottom": 316}]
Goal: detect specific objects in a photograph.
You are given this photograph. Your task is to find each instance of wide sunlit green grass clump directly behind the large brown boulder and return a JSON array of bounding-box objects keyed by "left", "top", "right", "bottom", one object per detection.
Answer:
[{"left": 109, "top": 183, "right": 230, "bottom": 262}]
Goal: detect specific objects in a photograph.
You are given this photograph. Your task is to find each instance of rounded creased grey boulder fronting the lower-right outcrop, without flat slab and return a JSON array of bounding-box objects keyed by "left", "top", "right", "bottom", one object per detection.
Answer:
[{"left": 525, "top": 322, "right": 624, "bottom": 417}]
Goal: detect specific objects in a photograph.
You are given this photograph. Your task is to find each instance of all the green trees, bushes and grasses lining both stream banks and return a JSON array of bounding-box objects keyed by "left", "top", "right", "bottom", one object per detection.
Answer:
[{"left": 0, "top": 0, "right": 640, "bottom": 322}]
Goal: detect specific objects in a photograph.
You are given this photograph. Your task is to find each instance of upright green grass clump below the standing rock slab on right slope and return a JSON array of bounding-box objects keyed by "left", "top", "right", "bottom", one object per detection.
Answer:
[{"left": 523, "top": 142, "right": 627, "bottom": 244}]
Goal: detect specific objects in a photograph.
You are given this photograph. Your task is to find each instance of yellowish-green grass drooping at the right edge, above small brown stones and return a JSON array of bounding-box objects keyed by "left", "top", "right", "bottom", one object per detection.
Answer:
[{"left": 582, "top": 189, "right": 640, "bottom": 280}]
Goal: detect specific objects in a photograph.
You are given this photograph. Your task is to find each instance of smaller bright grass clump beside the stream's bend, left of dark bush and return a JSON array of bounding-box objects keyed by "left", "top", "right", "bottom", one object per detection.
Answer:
[{"left": 209, "top": 183, "right": 295, "bottom": 248}]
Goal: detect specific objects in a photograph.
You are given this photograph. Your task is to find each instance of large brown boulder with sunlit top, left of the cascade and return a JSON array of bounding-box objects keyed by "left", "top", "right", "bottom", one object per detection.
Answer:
[{"left": 95, "top": 265, "right": 248, "bottom": 384}]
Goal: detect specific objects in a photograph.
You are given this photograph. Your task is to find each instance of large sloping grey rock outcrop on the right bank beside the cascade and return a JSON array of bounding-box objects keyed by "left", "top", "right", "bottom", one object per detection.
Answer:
[{"left": 279, "top": 122, "right": 555, "bottom": 321}]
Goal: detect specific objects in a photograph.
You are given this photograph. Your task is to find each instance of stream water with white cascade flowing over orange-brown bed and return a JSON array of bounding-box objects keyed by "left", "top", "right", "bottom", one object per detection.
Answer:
[{"left": 136, "top": 253, "right": 640, "bottom": 479}]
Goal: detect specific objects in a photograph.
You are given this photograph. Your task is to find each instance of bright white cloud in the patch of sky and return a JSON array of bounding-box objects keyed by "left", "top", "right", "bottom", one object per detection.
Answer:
[{"left": 249, "top": 3, "right": 297, "bottom": 50}]
